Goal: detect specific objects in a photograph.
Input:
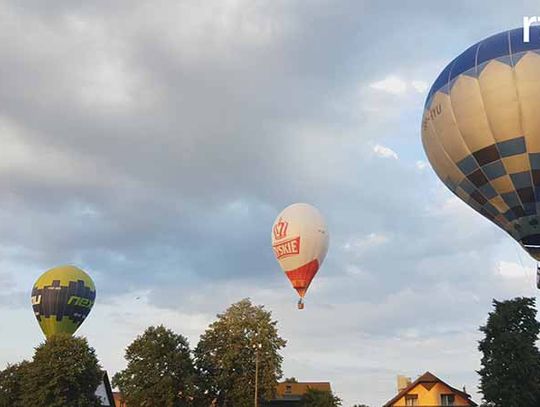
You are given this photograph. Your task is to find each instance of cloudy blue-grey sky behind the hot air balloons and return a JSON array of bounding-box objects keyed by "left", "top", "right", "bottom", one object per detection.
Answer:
[{"left": 0, "top": 0, "right": 540, "bottom": 407}]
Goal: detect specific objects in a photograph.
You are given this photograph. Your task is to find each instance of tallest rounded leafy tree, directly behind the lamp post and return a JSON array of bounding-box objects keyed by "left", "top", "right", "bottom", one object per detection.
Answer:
[{"left": 195, "top": 299, "right": 286, "bottom": 407}]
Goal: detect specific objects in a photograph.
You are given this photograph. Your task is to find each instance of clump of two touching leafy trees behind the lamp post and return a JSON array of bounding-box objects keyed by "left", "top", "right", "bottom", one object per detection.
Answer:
[{"left": 113, "top": 300, "right": 286, "bottom": 407}]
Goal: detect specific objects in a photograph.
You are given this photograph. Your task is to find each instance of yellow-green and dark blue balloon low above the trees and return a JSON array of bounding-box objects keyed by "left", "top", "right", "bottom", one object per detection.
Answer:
[{"left": 32, "top": 266, "right": 96, "bottom": 338}]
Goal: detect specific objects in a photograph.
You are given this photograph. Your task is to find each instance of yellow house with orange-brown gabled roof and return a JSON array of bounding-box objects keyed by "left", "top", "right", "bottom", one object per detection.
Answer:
[{"left": 383, "top": 372, "right": 477, "bottom": 407}]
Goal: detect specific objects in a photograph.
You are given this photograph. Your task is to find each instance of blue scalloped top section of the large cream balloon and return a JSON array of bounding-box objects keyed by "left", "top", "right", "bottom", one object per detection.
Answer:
[{"left": 426, "top": 25, "right": 540, "bottom": 107}]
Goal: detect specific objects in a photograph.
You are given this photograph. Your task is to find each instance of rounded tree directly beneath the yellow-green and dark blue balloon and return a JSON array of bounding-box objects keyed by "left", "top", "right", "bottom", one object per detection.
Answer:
[{"left": 22, "top": 334, "right": 103, "bottom": 407}]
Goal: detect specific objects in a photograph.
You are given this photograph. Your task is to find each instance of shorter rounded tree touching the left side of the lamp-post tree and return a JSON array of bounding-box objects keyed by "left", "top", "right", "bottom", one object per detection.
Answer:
[{"left": 113, "top": 325, "right": 194, "bottom": 407}]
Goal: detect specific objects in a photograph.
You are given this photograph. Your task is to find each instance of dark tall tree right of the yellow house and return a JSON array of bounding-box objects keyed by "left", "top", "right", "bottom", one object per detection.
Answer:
[{"left": 478, "top": 298, "right": 540, "bottom": 407}]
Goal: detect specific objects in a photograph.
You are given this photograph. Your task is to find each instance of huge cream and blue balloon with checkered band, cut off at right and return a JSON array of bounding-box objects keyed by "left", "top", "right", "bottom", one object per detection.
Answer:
[{"left": 422, "top": 27, "right": 540, "bottom": 280}]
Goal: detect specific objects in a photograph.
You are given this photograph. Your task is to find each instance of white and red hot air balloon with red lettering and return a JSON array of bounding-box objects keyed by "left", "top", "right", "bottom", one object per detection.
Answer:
[{"left": 272, "top": 203, "right": 329, "bottom": 309}]
